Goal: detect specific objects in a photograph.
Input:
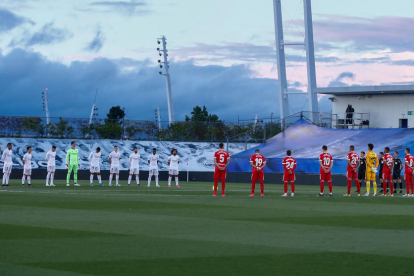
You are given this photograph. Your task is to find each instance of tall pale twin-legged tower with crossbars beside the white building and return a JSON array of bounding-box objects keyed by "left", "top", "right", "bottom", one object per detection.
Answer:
[{"left": 273, "top": 0, "right": 318, "bottom": 128}]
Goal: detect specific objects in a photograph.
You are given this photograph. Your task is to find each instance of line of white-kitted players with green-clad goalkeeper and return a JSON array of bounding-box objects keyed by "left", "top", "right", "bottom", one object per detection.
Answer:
[{"left": 0, "top": 141, "right": 180, "bottom": 188}]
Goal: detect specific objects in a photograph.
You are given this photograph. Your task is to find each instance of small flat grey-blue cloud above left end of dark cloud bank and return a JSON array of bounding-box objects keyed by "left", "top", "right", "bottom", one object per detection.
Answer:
[{"left": 9, "top": 23, "right": 72, "bottom": 47}]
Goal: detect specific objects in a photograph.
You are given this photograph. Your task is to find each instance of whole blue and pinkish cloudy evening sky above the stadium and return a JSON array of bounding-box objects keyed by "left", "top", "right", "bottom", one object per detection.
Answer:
[{"left": 0, "top": 0, "right": 414, "bottom": 121}]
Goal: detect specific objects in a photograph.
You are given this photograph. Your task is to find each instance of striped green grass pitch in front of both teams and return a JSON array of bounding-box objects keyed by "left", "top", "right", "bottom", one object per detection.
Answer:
[{"left": 0, "top": 180, "right": 414, "bottom": 276}]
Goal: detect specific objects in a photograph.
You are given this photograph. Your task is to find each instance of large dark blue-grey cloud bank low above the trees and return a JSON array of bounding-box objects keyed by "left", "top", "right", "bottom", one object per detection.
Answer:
[{"left": 0, "top": 49, "right": 332, "bottom": 121}]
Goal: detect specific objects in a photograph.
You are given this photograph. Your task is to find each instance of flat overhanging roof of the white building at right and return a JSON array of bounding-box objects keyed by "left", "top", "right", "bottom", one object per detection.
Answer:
[{"left": 314, "top": 85, "right": 414, "bottom": 95}]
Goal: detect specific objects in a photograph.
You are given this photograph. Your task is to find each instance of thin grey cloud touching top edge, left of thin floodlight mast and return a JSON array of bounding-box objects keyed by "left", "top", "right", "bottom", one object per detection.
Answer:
[{"left": 89, "top": 0, "right": 150, "bottom": 15}]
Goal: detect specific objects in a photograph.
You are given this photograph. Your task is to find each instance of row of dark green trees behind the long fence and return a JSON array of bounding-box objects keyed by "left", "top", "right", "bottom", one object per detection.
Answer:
[{"left": 0, "top": 106, "right": 281, "bottom": 141}]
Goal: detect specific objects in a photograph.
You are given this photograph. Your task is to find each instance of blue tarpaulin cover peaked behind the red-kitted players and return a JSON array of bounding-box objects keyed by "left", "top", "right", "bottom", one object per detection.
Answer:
[{"left": 228, "top": 119, "right": 414, "bottom": 174}]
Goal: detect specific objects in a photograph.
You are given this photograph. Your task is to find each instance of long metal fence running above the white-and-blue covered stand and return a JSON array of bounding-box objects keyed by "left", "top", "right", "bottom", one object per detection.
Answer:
[{"left": 0, "top": 112, "right": 332, "bottom": 143}]
